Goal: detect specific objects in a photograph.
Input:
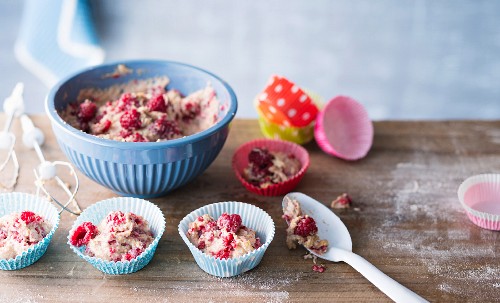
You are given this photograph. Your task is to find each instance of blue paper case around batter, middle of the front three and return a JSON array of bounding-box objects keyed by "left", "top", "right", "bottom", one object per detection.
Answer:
[{"left": 68, "top": 197, "right": 166, "bottom": 275}]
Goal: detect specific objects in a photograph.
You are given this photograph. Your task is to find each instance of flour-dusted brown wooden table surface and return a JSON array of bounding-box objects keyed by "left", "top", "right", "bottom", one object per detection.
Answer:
[{"left": 0, "top": 115, "right": 500, "bottom": 302}]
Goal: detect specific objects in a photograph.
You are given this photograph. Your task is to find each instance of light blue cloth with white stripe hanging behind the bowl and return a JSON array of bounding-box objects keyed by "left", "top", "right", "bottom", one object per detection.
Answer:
[{"left": 15, "top": 0, "right": 104, "bottom": 87}]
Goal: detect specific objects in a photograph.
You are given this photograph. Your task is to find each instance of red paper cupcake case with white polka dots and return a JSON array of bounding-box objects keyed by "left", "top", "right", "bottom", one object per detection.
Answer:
[{"left": 257, "top": 75, "right": 318, "bottom": 127}]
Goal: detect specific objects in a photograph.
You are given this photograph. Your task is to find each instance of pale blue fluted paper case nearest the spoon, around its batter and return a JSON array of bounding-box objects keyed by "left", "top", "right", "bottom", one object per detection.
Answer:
[{"left": 179, "top": 201, "right": 275, "bottom": 277}]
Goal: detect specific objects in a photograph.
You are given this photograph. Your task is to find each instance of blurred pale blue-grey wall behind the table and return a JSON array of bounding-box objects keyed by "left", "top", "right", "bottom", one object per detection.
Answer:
[{"left": 0, "top": 0, "right": 500, "bottom": 120}]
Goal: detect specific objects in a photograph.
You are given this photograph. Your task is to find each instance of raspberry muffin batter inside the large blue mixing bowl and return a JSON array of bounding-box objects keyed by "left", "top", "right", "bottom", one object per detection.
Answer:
[{"left": 59, "top": 77, "right": 220, "bottom": 142}]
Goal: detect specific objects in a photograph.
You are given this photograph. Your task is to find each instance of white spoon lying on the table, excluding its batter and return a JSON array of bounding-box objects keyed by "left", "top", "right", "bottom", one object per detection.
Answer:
[{"left": 283, "top": 193, "right": 428, "bottom": 303}]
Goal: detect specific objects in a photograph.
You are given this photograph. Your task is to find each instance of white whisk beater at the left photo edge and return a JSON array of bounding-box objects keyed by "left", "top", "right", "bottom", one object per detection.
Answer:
[{"left": 0, "top": 83, "right": 24, "bottom": 190}]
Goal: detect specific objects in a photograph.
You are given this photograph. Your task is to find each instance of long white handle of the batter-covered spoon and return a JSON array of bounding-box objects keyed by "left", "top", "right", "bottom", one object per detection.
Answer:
[{"left": 335, "top": 248, "right": 428, "bottom": 303}]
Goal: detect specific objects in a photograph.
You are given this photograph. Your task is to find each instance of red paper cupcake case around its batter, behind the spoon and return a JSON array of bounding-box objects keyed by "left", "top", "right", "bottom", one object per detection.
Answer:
[{"left": 232, "top": 139, "right": 309, "bottom": 196}]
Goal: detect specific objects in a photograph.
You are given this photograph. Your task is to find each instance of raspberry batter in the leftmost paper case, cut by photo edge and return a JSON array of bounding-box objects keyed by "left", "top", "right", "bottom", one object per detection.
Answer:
[{"left": 0, "top": 211, "right": 52, "bottom": 259}]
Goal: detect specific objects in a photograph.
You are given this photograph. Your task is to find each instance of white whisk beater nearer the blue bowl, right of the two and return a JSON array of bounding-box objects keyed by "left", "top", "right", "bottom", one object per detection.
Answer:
[{"left": 21, "top": 115, "right": 82, "bottom": 215}]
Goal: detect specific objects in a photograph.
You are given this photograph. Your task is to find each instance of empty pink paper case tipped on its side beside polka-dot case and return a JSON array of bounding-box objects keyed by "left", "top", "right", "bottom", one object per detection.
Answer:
[{"left": 314, "top": 96, "right": 373, "bottom": 160}]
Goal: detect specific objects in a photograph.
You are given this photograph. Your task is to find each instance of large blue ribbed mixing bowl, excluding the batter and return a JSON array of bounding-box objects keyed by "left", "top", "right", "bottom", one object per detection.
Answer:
[{"left": 45, "top": 60, "right": 238, "bottom": 198}]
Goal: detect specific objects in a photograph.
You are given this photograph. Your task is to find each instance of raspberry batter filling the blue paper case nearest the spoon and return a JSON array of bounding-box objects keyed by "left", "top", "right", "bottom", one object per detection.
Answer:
[{"left": 187, "top": 213, "right": 262, "bottom": 259}]
